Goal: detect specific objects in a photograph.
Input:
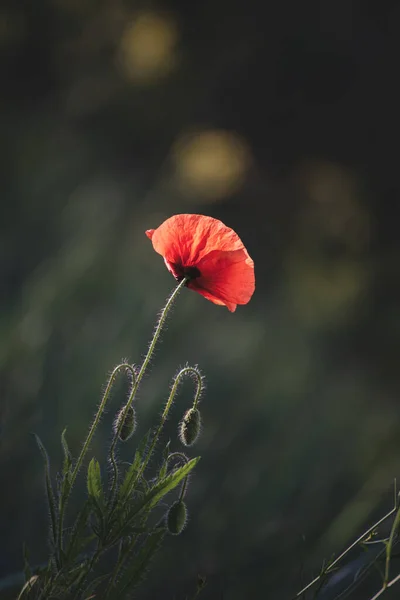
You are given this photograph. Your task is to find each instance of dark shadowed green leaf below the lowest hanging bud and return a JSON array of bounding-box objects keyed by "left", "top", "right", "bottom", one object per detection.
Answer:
[{"left": 114, "top": 527, "right": 165, "bottom": 598}]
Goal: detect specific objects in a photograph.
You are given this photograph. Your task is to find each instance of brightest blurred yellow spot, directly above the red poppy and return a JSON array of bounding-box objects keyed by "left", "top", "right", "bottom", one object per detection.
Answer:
[{"left": 172, "top": 130, "right": 251, "bottom": 201}]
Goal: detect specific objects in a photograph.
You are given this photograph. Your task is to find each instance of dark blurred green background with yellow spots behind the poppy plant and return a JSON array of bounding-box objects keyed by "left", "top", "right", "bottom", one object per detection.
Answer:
[{"left": 0, "top": 0, "right": 400, "bottom": 600}]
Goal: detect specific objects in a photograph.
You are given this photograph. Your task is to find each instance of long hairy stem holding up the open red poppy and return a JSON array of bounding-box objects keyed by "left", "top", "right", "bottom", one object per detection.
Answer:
[{"left": 110, "top": 278, "right": 188, "bottom": 504}]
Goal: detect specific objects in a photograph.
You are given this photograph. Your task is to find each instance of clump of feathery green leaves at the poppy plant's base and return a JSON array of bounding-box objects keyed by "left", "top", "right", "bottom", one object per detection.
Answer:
[{"left": 21, "top": 433, "right": 199, "bottom": 600}]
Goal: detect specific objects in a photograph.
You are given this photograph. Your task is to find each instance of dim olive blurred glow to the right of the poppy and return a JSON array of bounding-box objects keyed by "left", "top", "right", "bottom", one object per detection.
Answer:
[{"left": 286, "top": 161, "right": 371, "bottom": 328}]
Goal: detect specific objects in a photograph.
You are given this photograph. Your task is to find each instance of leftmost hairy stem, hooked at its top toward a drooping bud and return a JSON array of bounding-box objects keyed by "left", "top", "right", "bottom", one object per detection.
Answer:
[{"left": 57, "top": 363, "right": 136, "bottom": 561}]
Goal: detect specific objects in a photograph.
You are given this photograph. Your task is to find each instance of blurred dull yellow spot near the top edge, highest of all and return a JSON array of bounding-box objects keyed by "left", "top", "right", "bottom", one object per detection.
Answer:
[{"left": 119, "top": 11, "right": 178, "bottom": 84}]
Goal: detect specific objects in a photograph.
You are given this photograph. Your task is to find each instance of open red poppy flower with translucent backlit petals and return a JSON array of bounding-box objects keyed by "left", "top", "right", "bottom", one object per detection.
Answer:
[{"left": 146, "top": 215, "right": 255, "bottom": 312}]
